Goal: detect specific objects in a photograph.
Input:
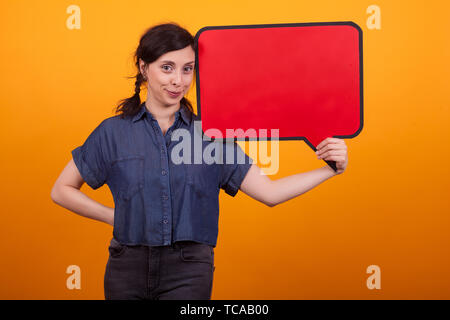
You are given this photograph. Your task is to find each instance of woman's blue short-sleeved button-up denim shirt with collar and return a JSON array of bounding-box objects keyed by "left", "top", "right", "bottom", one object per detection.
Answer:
[{"left": 72, "top": 103, "right": 253, "bottom": 247}]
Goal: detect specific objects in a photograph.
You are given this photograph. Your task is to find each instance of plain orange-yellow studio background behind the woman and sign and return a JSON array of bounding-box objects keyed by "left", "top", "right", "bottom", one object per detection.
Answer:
[{"left": 0, "top": 0, "right": 450, "bottom": 299}]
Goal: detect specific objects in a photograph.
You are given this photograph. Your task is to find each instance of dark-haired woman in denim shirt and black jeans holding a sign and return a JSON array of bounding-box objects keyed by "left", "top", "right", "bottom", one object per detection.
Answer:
[{"left": 51, "top": 23, "right": 347, "bottom": 299}]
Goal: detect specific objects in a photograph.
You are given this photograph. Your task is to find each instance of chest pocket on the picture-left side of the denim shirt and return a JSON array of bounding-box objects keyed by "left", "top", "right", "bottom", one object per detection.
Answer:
[{"left": 111, "top": 156, "right": 144, "bottom": 200}]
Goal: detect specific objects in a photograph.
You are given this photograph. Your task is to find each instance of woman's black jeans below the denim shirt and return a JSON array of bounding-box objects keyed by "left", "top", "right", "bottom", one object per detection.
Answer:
[{"left": 104, "top": 238, "right": 215, "bottom": 300}]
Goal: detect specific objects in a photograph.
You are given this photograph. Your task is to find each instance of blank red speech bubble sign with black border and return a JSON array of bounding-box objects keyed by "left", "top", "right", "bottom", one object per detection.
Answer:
[{"left": 195, "top": 22, "right": 363, "bottom": 170}]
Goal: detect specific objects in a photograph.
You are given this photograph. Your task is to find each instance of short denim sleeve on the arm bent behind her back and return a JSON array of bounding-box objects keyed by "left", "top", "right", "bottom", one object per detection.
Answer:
[{"left": 72, "top": 122, "right": 109, "bottom": 190}]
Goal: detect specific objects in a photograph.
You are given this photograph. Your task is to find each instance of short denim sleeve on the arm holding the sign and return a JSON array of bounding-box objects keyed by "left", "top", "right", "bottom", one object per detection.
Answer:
[{"left": 220, "top": 142, "right": 253, "bottom": 197}]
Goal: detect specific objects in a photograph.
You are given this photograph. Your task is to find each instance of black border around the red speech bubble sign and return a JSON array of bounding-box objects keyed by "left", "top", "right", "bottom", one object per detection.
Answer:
[{"left": 194, "top": 21, "right": 364, "bottom": 151}]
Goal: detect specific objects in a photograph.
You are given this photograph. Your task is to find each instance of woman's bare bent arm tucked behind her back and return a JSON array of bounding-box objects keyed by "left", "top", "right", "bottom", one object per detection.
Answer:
[{"left": 51, "top": 159, "right": 114, "bottom": 226}]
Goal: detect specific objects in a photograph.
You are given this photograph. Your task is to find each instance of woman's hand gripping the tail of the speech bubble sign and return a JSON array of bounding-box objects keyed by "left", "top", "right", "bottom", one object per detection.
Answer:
[{"left": 316, "top": 138, "right": 348, "bottom": 174}]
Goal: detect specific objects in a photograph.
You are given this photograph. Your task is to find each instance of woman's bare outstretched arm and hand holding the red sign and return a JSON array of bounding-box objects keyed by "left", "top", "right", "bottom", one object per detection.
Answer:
[{"left": 240, "top": 138, "right": 348, "bottom": 207}]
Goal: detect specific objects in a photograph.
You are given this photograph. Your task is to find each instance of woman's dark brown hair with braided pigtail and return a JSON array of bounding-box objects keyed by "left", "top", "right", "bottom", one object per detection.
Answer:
[{"left": 116, "top": 22, "right": 196, "bottom": 118}]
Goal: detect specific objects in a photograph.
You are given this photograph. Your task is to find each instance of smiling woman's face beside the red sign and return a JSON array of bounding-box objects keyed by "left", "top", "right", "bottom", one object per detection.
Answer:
[{"left": 139, "top": 46, "right": 195, "bottom": 107}]
